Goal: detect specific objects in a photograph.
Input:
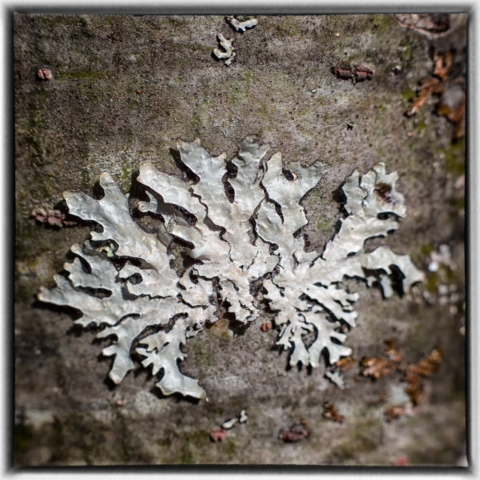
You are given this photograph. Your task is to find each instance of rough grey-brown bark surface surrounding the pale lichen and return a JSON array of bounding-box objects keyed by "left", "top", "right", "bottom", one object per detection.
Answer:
[{"left": 14, "top": 14, "right": 467, "bottom": 466}]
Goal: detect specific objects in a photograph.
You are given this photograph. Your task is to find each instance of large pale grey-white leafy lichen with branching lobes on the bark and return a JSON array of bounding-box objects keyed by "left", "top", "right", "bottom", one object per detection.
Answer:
[{"left": 39, "top": 136, "right": 423, "bottom": 398}]
